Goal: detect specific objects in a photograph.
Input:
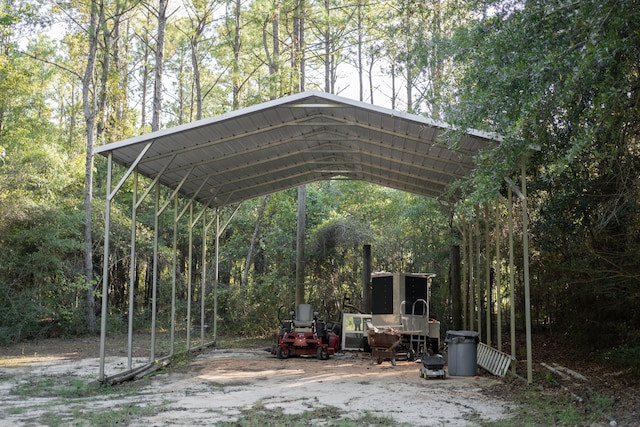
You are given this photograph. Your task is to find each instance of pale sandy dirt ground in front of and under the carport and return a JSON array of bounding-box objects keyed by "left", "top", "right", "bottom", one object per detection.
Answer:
[{"left": 0, "top": 338, "right": 640, "bottom": 426}]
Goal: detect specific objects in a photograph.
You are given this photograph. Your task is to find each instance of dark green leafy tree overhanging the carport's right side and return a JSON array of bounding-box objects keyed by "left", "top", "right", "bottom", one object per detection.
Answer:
[{"left": 447, "top": 0, "right": 640, "bottom": 344}]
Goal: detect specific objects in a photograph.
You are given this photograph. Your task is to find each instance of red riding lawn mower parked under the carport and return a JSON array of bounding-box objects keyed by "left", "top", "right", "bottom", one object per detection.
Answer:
[{"left": 272, "top": 304, "right": 340, "bottom": 360}]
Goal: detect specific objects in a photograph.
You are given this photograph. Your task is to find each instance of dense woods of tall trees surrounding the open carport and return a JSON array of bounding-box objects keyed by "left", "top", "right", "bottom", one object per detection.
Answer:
[{"left": 0, "top": 0, "right": 640, "bottom": 364}]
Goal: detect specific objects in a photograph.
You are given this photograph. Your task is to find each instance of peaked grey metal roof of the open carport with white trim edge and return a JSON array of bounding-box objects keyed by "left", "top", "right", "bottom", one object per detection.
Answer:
[{"left": 95, "top": 91, "right": 499, "bottom": 207}]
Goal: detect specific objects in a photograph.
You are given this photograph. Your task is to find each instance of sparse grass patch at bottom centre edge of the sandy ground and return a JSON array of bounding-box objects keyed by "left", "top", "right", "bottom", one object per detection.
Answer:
[{"left": 215, "top": 404, "right": 405, "bottom": 427}]
